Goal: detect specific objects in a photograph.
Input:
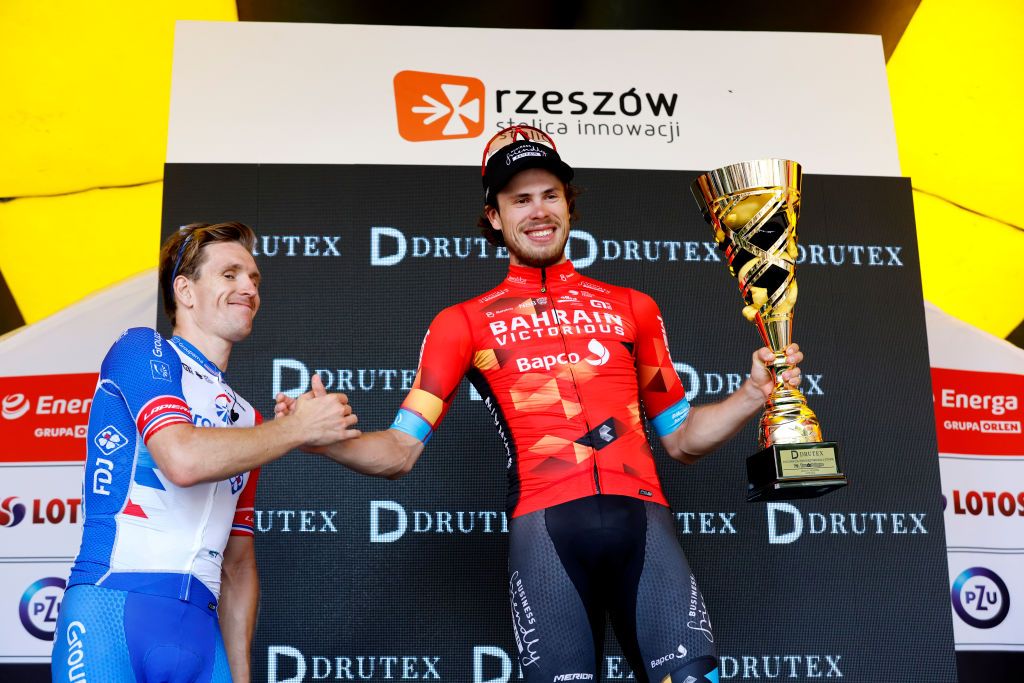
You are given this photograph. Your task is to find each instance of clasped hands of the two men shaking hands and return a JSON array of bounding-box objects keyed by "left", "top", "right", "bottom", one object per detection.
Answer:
[{"left": 273, "top": 374, "right": 361, "bottom": 453}]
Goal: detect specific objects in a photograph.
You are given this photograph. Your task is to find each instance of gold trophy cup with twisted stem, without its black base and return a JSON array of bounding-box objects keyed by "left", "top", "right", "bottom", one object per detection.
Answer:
[{"left": 690, "top": 159, "right": 821, "bottom": 447}]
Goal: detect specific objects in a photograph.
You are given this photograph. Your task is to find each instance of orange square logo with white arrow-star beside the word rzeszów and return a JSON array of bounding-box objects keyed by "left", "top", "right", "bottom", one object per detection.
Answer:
[{"left": 394, "top": 71, "right": 484, "bottom": 142}]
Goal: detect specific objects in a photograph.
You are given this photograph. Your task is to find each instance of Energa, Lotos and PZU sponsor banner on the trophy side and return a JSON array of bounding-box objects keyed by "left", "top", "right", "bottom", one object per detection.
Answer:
[{"left": 927, "top": 307, "right": 1024, "bottom": 680}]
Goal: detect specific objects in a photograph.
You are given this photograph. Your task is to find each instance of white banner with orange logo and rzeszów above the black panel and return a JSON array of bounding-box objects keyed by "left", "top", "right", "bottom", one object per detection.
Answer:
[{"left": 167, "top": 22, "right": 900, "bottom": 176}]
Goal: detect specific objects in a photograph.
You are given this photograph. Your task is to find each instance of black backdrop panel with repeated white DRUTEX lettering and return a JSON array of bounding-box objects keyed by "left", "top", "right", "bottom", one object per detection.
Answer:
[{"left": 162, "top": 164, "right": 956, "bottom": 683}]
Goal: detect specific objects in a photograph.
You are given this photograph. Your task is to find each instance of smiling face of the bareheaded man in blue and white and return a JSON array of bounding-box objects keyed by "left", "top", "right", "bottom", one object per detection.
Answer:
[{"left": 174, "top": 242, "right": 260, "bottom": 343}]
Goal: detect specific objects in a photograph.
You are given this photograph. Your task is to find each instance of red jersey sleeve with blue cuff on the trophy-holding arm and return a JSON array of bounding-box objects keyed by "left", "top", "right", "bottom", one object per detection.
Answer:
[{"left": 630, "top": 291, "right": 690, "bottom": 436}]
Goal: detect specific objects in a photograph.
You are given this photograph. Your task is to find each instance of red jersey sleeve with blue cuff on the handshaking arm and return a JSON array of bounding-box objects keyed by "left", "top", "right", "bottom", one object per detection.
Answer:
[{"left": 391, "top": 306, "right": 473, "bottom": 443}]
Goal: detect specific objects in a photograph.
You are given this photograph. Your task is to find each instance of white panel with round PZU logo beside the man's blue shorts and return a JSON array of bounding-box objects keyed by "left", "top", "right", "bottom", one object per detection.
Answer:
[{"left": 0, "top": 560, "right": 71, "bottom": 664}]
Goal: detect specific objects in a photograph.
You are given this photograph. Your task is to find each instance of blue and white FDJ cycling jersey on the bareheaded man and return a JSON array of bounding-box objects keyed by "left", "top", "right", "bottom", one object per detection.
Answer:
[{"left": 69, "top": 328, "right": 261, "bottom": 599}]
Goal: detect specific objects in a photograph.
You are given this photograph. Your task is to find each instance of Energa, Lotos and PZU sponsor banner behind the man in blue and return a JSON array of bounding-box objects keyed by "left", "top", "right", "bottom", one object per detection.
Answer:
[{"left": 0, "top": 271, "right": 157, "bottom": 671}]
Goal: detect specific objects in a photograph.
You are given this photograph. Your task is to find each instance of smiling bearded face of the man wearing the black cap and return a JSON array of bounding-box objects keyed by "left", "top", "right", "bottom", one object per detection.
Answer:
[{"left": 484, "top": 168, "right": 569, "bottom": 268}]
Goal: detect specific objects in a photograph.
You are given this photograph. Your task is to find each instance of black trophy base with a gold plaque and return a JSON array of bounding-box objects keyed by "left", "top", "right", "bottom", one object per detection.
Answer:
[{"left": 746, "top": 441, "right": 848, "bottom": 503}]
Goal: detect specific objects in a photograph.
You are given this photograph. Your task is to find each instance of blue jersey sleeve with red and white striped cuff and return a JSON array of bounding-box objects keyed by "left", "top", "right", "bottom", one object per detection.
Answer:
[{"left": 99, "top": 328, "right": 193, "bottom": 443}]
